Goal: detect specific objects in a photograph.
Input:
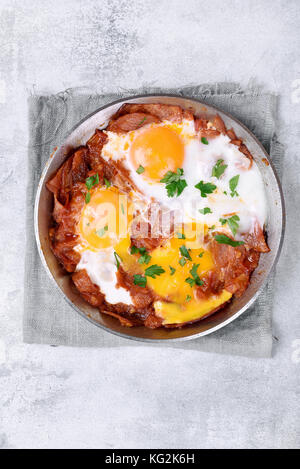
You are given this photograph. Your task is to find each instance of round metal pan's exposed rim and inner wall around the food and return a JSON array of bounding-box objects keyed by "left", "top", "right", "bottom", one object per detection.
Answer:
[{"left": 34, "top": 95, "right": 285, "bottom": 342}]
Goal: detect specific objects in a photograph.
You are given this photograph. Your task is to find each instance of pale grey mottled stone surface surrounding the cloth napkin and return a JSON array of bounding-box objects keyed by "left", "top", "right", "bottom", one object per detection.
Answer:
[{"left": 0, "top": 0, "right": 300, "bottom": 448}]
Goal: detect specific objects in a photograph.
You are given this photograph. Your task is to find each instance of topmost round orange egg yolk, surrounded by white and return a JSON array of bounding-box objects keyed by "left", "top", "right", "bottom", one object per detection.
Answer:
[{"left": 130, "top": 127, "right": 184, "bottom": 181}]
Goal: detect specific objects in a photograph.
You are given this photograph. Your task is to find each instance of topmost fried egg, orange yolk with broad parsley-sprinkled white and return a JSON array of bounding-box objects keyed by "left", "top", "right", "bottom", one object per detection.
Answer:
[{"left": 102, "top": 119, "right": 267, "bottom": 235}]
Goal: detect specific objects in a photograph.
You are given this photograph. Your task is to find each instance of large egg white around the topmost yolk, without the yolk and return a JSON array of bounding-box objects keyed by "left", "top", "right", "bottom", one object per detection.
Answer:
[{"left": 102, "top": 120, "right": 267, "bottom": 237}]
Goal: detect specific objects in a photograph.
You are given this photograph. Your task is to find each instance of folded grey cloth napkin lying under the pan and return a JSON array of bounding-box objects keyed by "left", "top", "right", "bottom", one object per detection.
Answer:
[{"left": 23, "top": 83, "right": 283, "bottom": 357}]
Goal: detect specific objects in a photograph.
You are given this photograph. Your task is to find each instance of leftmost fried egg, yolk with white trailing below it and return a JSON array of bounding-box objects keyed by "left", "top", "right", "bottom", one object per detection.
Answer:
[{"left": 76, "top": 187, "right": 132, "bottom": 305}]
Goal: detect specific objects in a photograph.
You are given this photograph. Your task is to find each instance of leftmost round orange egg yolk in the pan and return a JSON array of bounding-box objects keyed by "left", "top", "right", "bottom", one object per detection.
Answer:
[{"left": 78, "top": 187, "right": 130, "bottom": 250}]
